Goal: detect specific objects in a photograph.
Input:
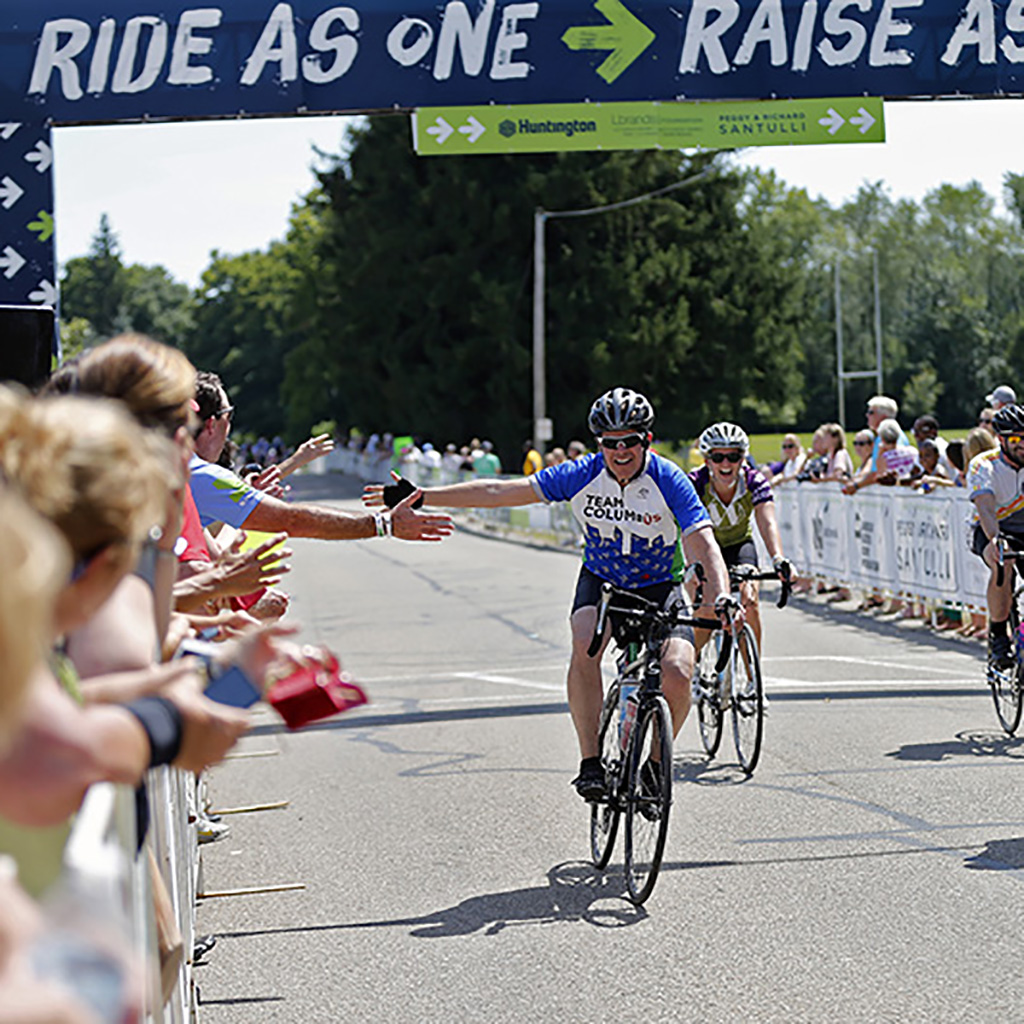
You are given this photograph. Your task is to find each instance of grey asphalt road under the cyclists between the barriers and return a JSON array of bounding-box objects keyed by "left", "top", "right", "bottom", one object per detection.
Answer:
[{"left": 197, "top": 481, "right": 1024, "bottom": 1024}]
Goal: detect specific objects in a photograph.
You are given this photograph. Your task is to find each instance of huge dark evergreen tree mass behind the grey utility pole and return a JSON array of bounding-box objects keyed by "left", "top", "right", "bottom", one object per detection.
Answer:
[{"left": 286, "top": 118, "right": 802, "bottom": 453}]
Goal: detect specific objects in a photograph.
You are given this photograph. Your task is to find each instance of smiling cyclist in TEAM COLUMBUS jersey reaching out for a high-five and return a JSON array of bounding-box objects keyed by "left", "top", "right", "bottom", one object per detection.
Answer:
[{"left": 365, "top": 387, "right": 733, "bottom": 800}]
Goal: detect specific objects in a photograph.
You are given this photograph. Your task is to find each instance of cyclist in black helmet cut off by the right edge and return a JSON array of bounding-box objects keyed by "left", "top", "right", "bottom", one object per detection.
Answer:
[{"left": 967, "top": 406, "right": 1024, "bottom": 671}]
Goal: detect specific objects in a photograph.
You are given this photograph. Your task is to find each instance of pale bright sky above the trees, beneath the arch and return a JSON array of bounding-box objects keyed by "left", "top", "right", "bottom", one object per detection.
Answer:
[{"left": 53, "top": 99, "right": 1024, "bottom": 287}]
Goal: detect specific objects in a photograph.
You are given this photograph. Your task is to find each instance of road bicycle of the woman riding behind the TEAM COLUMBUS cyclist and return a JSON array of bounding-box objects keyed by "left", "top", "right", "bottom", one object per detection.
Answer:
[{"left": 693, "top": 565, "right": 793, "bottom": 775}]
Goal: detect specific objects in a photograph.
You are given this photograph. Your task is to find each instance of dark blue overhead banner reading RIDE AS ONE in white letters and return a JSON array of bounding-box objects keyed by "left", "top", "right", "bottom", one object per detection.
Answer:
[{"left": 6, "top": 0, "right": 1024, "bottom": 125}]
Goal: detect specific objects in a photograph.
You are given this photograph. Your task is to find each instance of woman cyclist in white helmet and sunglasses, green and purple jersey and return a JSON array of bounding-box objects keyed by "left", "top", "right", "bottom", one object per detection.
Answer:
[{"left": 689, "top": 422, "right": 795, "bottom": 649}]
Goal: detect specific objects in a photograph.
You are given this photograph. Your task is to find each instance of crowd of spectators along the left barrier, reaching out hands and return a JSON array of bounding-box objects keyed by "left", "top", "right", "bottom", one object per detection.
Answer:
[{"left": 0, "top": 335, "right": 452, "bottom": 1024}]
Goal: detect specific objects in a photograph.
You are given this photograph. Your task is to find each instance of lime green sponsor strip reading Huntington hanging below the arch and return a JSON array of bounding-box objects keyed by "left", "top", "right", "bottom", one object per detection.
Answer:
[{"left": 413, "top": 97, "right": 886, "bottom": 157}]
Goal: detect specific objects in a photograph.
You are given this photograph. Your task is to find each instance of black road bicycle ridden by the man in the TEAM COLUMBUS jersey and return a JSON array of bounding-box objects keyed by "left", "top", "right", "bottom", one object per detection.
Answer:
[{"left": 589, "top": 570, "right": 729, "bottom": 904}]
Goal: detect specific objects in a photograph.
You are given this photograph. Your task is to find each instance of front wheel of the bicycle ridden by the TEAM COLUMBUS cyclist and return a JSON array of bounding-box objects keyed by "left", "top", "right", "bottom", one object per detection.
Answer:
[{"left": 625, "top": 696, "right": 672, "bottom": 904}]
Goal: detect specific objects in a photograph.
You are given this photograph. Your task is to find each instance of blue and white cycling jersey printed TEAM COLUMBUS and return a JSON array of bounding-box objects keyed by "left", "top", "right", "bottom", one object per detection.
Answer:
[{"left": 529, "top": 452, "right": 711, "bottom": 590}]
